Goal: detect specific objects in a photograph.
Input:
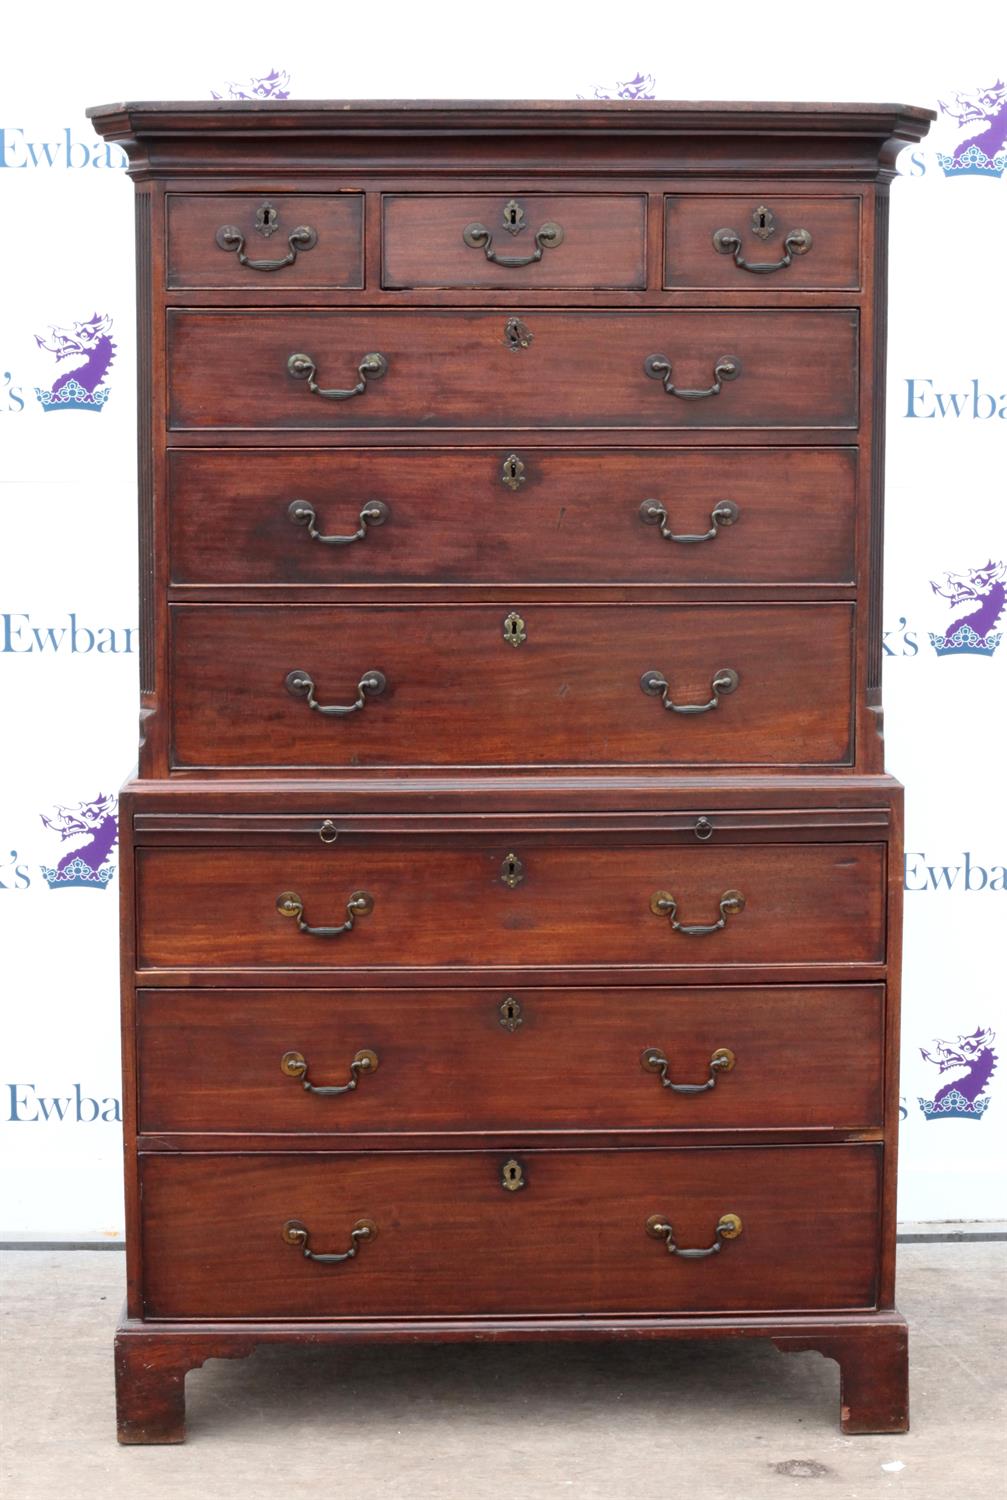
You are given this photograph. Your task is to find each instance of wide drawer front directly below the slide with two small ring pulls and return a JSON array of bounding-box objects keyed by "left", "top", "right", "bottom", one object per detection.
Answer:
[{"left": 137, "top": 836, "right": 885, "bottom": 972}]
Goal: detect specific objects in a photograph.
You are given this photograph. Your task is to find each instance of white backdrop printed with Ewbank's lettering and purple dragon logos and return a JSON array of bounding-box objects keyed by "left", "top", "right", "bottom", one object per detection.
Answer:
[{"left": 0, "top": 0, "right": 1007, "bottom": 1241}]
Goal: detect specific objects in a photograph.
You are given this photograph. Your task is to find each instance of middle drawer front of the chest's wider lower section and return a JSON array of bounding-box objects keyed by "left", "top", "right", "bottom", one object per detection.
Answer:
[{"left": 137, "top": 986, "right": 884, "bottom": 1136}]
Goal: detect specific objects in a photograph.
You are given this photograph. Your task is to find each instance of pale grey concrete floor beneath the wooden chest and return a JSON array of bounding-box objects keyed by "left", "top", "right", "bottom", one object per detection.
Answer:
[{"left": 0, "top": 1242, "right": 1007, "bottom": 1500}]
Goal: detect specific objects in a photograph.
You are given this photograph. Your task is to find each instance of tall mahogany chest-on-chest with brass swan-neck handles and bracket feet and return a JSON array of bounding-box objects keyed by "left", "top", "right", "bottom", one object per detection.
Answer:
[{"left": 90, "top": 93, "right": 932, "bottom": 1443}]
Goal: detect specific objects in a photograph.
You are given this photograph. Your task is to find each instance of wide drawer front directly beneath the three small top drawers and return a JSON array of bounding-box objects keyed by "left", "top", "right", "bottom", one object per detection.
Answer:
[{"left": 167, "top": 308, "right": 858, "bottom": 441}]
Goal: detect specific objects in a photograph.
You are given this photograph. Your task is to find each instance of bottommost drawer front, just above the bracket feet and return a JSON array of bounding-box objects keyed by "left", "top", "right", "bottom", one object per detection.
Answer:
[{"left": 141, "top": 1146, "right": 881, "bottom": 1319}]
